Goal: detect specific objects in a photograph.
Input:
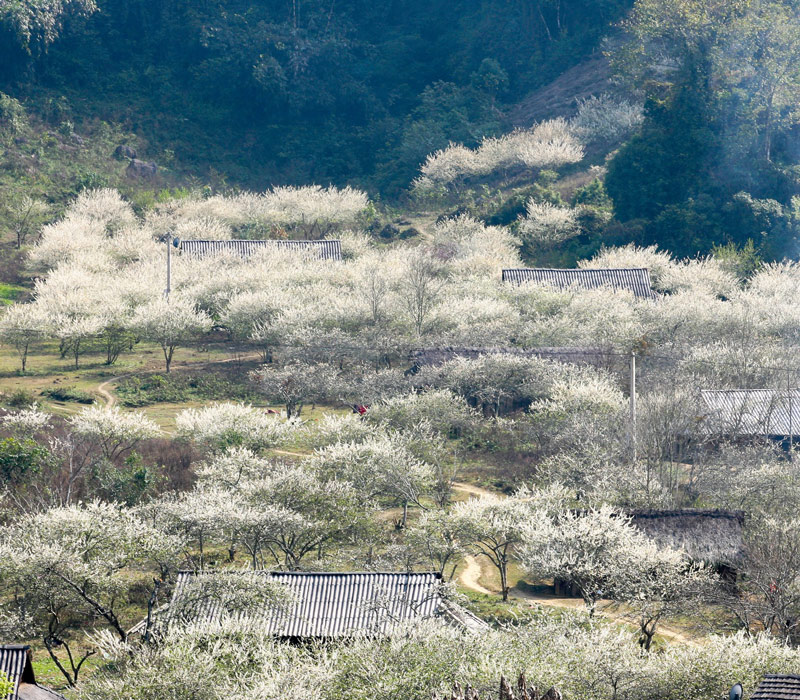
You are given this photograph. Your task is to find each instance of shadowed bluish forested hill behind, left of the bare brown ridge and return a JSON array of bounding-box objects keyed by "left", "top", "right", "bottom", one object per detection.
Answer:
[{"left": 0, "top": 0, "right": 632, "bottom": 191}]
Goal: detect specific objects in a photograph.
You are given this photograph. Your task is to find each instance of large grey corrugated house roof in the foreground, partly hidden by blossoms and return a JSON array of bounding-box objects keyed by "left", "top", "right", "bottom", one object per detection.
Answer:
[{"left": 129, "top": 571, "right": 487, "bottom": 641}]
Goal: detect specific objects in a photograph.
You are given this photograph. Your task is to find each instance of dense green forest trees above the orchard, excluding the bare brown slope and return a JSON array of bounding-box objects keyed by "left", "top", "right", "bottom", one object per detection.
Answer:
[{"left": 0, "top": 0, "right": 800, "bottom": 259}]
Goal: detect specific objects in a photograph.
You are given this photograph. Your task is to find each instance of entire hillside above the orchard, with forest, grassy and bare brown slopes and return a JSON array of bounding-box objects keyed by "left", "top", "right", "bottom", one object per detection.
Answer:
[{"left": 0, "top": 0, "right": 800, "bottom": 262}]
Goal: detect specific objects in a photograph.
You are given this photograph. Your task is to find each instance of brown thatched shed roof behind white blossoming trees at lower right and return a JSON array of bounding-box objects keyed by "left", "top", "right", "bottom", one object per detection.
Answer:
[{"left": 628, "top": 508, "right": 744, "bottom": 566}]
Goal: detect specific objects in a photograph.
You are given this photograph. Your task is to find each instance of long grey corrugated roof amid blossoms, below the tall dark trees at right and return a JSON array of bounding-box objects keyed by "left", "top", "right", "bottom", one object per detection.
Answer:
[{"left": 503, "top": 267, "right": 656, "bottom": 299}]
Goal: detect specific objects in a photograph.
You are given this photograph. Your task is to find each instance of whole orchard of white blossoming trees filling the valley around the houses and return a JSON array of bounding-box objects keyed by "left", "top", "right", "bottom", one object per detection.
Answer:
[{"left": 0, "top": 60, "right": 800, "bottom": 700}]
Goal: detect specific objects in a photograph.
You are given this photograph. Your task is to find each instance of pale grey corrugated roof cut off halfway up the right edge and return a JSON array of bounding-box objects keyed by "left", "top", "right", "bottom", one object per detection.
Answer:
[{"left": 700, "top": 389, "right": 800, "bottom": 436}]
